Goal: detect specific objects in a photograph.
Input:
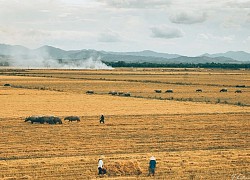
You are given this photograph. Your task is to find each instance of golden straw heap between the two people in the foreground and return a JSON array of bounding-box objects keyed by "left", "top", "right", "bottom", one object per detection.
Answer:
[{"left": 105, "top": 161, "right": 142, "bottom": 176}]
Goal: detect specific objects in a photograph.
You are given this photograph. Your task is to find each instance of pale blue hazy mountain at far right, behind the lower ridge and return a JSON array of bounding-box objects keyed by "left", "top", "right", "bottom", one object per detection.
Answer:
[{"left": 202, "top": 51, "right": 250, "bottom": 62}]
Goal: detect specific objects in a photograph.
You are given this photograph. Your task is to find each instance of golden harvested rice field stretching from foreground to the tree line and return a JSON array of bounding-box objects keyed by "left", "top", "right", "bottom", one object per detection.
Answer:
[{"left": 0, "top": 69, "right": 250, "bottom": 180}]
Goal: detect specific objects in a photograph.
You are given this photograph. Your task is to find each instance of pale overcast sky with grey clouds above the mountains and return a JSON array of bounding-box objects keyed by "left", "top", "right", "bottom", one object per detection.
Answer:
[{"left": 0, "top": 0, "right": 250, "bottom": 56}]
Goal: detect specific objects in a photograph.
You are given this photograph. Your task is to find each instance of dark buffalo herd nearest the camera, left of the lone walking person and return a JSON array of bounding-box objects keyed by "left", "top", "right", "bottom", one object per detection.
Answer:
[{"left": 24, "top": 116, "right": 80, "bottom": 124}]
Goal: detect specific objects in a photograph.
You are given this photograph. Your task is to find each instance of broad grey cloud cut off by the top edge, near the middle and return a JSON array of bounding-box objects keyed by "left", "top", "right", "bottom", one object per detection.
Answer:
[{"left": 99, "top": 0, "right": 171, "bottom": 8}]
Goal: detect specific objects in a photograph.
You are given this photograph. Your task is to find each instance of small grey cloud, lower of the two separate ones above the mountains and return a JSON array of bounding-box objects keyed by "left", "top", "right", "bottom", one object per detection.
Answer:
[{"left": 151, "top": 25, "right": 184, "bottom": 39}]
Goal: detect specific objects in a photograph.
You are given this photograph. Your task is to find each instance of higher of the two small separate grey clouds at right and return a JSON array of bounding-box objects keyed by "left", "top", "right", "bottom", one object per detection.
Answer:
[{"left": 169, "top": 12, "right": 207, "bottom": 24}]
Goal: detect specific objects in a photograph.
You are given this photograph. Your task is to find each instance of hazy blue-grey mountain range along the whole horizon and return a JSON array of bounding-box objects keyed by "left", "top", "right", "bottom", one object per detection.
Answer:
[{"left": 0, "top": 44, "right": 250, "bottom": 67}]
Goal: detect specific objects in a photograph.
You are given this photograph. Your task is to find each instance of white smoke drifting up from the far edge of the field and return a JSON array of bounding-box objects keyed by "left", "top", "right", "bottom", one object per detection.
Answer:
[{"left": 9, "top": 47, "right": 113, "bottom": 69}]
